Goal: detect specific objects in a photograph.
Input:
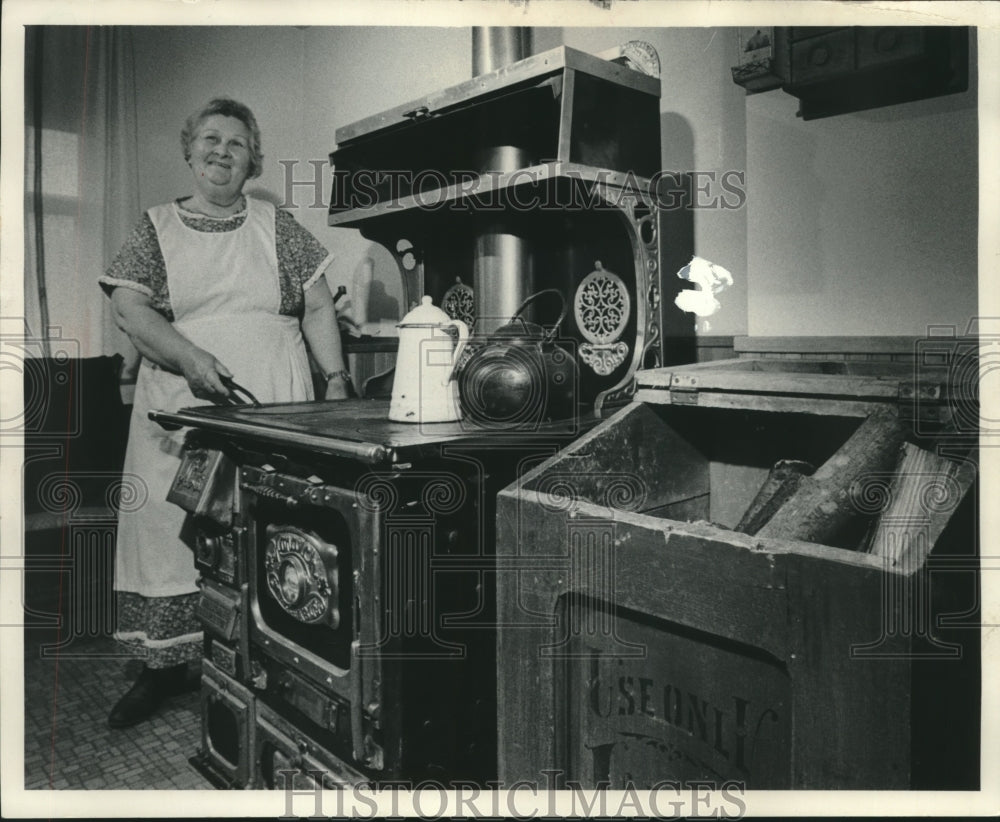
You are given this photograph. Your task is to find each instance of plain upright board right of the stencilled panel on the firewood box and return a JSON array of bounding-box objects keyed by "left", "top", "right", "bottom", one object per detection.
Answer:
[{"left": 787, "top": 555, "right": 911, "bottom": 790}]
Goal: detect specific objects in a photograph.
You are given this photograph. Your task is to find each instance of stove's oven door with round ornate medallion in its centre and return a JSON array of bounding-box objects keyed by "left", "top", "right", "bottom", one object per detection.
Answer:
[{"left": 240, "top": 466, "right": 391, "bottom": 772}]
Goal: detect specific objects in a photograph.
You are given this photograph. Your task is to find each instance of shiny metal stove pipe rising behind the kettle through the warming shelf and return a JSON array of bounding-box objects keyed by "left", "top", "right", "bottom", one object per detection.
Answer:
[{"left": 472, "top": 26, "right": 534, "bottom": 334}]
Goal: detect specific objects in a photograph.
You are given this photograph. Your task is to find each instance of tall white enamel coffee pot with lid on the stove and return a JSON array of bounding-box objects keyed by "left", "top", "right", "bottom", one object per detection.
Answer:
[{"left": 389, "top": 296, "right": 469, "bottom": 423}]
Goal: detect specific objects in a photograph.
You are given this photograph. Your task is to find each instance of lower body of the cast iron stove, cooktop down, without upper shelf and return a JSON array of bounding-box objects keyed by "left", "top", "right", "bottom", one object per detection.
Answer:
[{"left": 157, "top": 400, "right": 584, "bottom": 787}]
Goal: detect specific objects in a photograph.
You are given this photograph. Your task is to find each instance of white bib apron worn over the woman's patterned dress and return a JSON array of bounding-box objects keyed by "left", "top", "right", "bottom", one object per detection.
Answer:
[{"left": 115, "top": 198, "right": 313, "bottom": 597}]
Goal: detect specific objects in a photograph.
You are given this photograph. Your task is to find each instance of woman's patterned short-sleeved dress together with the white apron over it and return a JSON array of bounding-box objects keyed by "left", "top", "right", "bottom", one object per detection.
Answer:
[{"left": 99, "top": 198, "right": 332, "bottom": 668}]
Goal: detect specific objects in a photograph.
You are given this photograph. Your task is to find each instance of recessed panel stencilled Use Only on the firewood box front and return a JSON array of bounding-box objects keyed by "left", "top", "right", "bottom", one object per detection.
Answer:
[{"left": 553, "top": 594, "right": 792, "bottom": 790}]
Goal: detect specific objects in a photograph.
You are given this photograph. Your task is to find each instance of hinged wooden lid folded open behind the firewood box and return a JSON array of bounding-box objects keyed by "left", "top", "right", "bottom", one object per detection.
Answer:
[{"left": 635, "top": 357, "right": 964, "bottom": 421}]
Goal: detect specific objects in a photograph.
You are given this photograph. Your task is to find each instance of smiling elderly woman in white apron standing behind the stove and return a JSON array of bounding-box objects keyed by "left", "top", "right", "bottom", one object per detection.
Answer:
[{"left": 100, "top": 99, "right": 349, "bottom": 728}]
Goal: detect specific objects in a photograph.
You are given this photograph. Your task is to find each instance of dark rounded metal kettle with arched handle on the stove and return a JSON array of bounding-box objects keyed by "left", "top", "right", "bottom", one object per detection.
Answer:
[{"left": 457, "top": 288, "right": 579, "bottom": 426}]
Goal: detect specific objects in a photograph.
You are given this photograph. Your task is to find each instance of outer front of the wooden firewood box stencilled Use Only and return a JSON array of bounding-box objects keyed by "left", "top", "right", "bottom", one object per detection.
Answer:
[{"left": 498, "top": 490, "right": 968, "bottom": 789}]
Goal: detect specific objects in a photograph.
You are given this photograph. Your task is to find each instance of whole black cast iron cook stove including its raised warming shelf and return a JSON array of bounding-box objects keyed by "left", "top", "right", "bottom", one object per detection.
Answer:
[{"left": 152, "top": 44, "right": 672, "bottom": 788}]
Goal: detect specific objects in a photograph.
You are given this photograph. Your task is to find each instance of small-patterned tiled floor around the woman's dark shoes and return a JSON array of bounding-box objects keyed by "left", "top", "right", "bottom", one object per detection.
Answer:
[{"left": 24, "top": 629, "right": 212, "bottom": 790}]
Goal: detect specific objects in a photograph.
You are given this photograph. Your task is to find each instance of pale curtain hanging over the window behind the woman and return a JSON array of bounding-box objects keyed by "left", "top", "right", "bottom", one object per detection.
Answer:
[{"left": 24, "top": 26, "right": 139, "bottom": 364}]
